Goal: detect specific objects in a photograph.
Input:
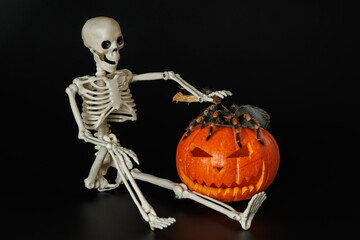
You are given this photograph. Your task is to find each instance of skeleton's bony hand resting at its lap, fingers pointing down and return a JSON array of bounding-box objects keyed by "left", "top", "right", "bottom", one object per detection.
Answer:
[{"left": 103, "top": 134, "right": 140, "bottom": 169}]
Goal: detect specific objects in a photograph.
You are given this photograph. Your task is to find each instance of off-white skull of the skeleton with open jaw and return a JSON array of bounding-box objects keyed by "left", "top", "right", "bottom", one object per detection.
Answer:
[{"left": 81, "top": 17, "right": 124, "bottom": 73}]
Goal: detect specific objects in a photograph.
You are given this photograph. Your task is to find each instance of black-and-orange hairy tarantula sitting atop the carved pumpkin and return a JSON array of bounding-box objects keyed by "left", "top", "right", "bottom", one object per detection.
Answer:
[{"left": 183, "top": 102, "right": 270, "bottom": 148}]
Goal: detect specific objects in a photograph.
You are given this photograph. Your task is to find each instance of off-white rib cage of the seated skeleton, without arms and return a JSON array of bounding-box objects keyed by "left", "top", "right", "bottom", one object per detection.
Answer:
[{"left": 73, "top": 70, "right": 136, "bottom": 130}]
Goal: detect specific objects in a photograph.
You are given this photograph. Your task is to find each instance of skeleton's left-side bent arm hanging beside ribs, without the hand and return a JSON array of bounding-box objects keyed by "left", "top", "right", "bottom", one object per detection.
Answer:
[{"left": 65, "top": 84, "right": 102, "bottom": 145}]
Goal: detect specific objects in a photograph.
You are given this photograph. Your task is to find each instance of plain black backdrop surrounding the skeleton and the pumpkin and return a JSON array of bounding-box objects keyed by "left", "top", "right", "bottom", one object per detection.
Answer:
[{"left": 0, "top": 0, "right": 359, "bottom": 239}]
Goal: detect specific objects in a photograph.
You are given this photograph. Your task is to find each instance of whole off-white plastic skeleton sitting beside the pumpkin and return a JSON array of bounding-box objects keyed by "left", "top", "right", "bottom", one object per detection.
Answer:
[{"left": 66, "top": 17, "right": 266, "bottom": 230}]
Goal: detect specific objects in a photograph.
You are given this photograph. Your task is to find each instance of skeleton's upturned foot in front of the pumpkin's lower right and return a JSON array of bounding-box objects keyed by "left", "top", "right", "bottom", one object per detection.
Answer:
[{"left": 239, "top": 192, "right": 266, "bottom": 230}]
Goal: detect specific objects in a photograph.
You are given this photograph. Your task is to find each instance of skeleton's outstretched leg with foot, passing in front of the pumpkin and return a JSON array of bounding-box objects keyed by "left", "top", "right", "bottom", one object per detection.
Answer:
[{"left": 131, "top": 168, "right": 266, "bottom": 230}]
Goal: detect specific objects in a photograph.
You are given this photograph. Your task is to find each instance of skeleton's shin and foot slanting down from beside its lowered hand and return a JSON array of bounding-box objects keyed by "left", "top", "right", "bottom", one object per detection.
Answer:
[{"left": 109, "top": 150, "right": 175, "bottom": 230}]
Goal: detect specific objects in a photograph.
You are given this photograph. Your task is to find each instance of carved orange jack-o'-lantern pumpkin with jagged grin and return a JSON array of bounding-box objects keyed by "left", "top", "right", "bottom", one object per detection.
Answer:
[{"left": 176, "top": 126, "right": 280, "bottom": 202}]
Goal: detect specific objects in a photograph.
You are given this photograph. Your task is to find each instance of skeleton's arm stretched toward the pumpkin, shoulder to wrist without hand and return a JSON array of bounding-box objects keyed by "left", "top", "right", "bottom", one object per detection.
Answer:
[{"left": 132, "top": 71, "right": 213, "bottom": 102}]
